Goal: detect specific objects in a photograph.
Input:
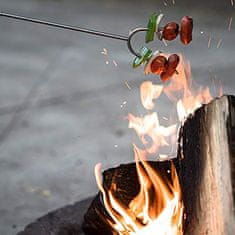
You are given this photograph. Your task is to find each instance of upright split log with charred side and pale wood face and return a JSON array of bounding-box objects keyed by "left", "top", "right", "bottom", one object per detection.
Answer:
[{"left": 178, "top": 96, "right": 235, "bottom": 235}]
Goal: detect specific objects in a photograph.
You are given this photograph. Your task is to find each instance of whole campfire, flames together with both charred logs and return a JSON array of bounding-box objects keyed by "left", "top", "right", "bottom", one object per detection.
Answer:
[{"left": 83, "top": 55, "right": 235, "bottom": 235}]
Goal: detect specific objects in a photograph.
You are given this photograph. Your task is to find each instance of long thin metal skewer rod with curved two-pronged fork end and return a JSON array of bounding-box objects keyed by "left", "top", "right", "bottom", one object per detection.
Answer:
[{"left": 0, "top": 12, "right": 148, "bottom": 57}]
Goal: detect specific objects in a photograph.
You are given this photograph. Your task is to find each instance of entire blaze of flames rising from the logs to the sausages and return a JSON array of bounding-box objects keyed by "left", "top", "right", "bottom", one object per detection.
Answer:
[{"left": 95, "top": 56, "right": 218, "bottom": 235}]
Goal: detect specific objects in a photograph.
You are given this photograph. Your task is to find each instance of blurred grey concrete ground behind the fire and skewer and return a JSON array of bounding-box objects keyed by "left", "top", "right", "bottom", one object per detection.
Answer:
[{"left": 0, "top": 0, "right": 235, "bottom": 235}]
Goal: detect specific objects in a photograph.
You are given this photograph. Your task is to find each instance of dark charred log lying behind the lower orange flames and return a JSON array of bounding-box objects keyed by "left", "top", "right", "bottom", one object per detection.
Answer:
[{"left": 82, "top": 161, "right": 178, "bottom": 235}]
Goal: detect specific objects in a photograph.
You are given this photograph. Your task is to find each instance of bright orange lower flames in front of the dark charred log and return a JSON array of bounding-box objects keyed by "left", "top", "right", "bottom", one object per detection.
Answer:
[{"left": 95, "top": 146, "right": 183, "bottom": 235}]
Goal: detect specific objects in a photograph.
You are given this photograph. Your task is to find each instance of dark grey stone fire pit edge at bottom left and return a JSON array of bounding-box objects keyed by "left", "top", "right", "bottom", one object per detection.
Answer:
[{"left": 17, "top": 197, "right": 94, "bottom": 235}]
